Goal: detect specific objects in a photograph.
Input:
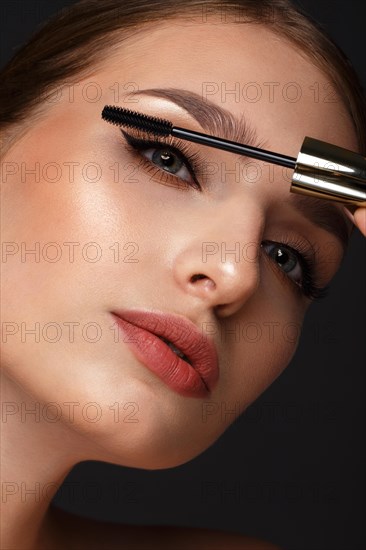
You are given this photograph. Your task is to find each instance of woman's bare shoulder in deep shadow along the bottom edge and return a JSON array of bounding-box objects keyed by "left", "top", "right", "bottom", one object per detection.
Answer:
[{"left": 38, "top": 508, "right": 281, "bottom": 550}]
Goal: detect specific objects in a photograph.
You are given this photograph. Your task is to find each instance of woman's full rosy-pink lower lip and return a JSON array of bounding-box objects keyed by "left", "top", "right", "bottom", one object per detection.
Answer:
[{"left": 116, "top": 317, "right": 209, "bottom": 397}]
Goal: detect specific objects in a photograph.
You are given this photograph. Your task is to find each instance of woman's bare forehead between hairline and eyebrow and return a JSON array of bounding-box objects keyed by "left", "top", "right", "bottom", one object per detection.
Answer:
[{"left": 103, "top": 19, "right": 357, "bottom": 156}]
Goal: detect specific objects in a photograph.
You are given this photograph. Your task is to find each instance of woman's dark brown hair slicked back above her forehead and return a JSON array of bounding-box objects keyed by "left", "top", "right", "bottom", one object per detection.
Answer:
[{"left": 0, "top": 0, "right": 366, "bottom": 154}]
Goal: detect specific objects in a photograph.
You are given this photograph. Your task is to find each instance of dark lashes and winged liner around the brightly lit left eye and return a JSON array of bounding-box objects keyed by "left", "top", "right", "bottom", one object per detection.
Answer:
[{"left": 121, "top": 130, "right": 206, "bottom": 190}]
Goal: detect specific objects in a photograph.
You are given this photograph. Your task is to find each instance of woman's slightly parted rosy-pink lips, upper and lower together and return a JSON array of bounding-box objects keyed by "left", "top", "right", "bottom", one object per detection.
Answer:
[{"left": 112, "top": 310, "right": 219, "bottom": 397}]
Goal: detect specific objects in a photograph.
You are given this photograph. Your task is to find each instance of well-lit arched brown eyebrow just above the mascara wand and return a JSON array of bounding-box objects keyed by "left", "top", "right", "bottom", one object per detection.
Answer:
[{"left": 128, "top": 88, "right": 266, "bottom": 148}]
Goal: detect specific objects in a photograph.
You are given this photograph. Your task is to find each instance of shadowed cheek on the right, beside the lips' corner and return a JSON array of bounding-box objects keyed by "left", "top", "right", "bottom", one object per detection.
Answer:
[{"left": 219, "top": 282, "right": 306, "bottom": 410}]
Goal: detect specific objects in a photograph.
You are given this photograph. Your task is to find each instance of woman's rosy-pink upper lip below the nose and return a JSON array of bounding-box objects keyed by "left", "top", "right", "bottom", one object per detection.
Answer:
[{"left": 113, "top": 310, "right": 219, "bottom": 391}]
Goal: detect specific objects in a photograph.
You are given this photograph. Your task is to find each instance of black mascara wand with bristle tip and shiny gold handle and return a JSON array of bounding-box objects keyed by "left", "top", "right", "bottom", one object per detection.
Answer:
[{"left": 102, "top": 105, "right": 366, "bottom": 206}]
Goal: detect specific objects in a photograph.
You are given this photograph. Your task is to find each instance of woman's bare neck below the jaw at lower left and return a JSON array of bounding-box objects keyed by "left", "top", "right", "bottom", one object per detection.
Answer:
[{"left": 0, "top": 373, "right": 87, "bottom": 550}]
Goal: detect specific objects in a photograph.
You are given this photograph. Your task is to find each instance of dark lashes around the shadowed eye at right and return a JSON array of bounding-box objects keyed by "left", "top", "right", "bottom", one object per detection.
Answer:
[{"left": 264, "top": 235, "right": 329, "bottom": 301}]
